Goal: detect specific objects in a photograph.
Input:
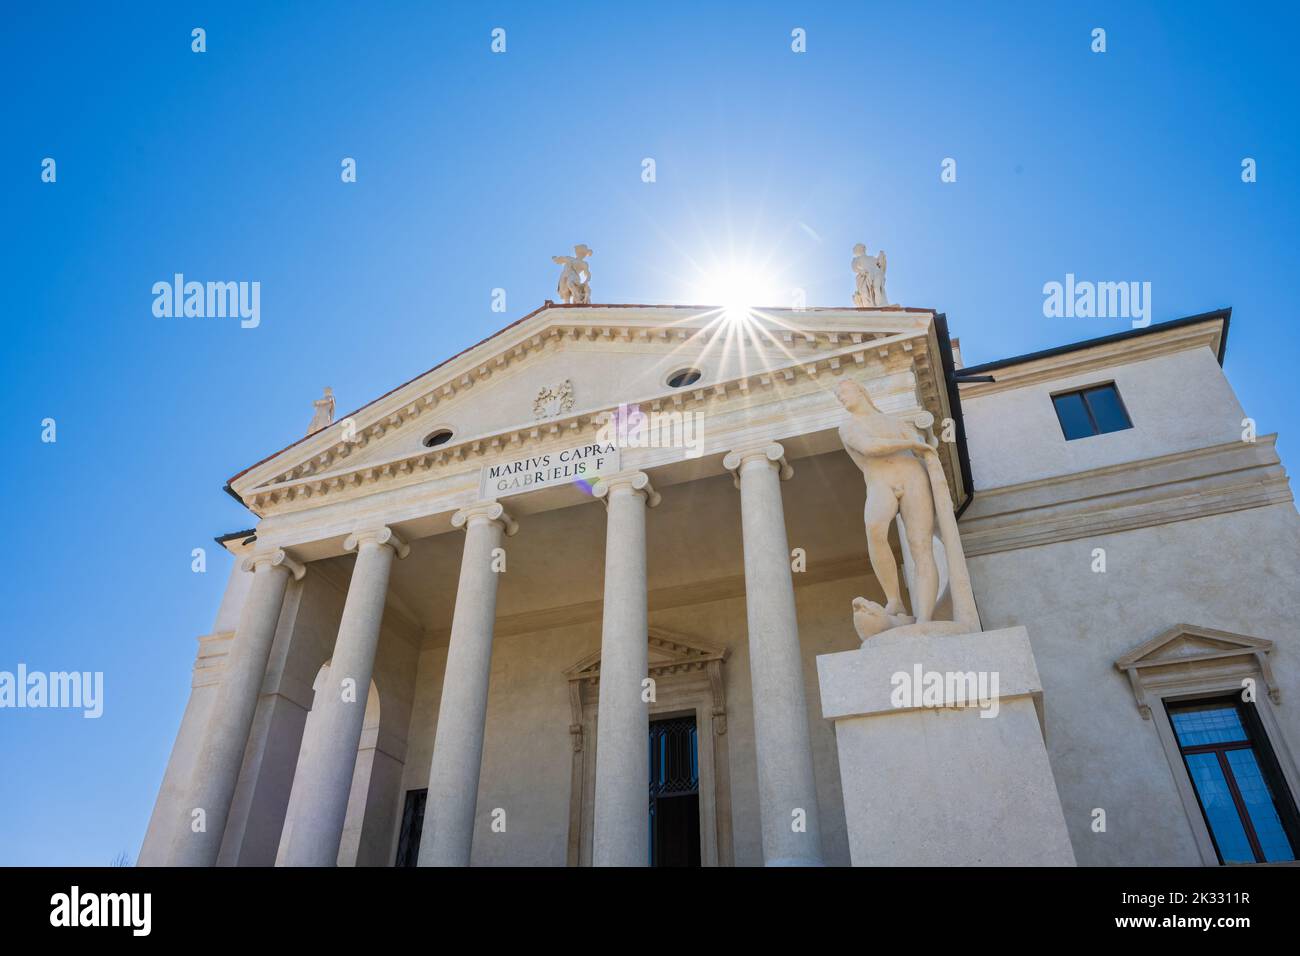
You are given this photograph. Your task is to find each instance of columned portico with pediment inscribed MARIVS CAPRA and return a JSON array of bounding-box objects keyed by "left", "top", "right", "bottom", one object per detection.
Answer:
[{"left": 147, "top": 306, "right": 977, "bottom": 865}]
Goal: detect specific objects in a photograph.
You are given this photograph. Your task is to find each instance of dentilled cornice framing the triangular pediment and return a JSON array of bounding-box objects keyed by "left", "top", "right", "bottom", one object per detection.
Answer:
[{"left": 233, "top": 307, "right": 946, "bottom": 516}]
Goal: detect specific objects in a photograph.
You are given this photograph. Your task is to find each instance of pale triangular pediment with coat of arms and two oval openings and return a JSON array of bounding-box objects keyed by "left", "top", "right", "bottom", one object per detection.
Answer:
[{"left": 230, "top": 306, "right": 943, "bottom": 514}]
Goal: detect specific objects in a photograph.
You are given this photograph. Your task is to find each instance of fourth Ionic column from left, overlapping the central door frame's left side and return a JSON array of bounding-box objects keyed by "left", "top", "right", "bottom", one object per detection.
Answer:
[{"left": 592, "top": 471, "right": 659, "bottom": 866}]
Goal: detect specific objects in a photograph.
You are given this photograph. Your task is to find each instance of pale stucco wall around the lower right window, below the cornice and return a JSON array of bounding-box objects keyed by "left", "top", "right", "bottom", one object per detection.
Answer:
[{"left": 970, "top": 505, "right": 1300, "bottom": 866}]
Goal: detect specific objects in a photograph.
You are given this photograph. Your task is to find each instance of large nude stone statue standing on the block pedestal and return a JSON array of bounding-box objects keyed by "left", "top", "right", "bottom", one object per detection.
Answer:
[{"left": 835, "top": 381, "right": 939, "bottom": 629}]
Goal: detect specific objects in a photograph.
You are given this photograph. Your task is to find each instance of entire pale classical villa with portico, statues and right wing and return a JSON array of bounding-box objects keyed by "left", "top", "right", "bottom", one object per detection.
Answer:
[{"left": 139, "top": 299, "right": 1300, "bottom": 866}]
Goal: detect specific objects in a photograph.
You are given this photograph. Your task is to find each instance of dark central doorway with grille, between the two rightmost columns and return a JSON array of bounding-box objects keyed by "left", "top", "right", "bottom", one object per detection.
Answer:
[{"left": 650, "top": 717, "right": 699, "bottom": 866}]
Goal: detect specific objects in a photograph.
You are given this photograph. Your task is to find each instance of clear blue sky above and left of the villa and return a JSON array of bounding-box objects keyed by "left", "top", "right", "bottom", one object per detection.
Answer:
[{"left": 0, "top": 3, "right": 1300, "bottom": 865}]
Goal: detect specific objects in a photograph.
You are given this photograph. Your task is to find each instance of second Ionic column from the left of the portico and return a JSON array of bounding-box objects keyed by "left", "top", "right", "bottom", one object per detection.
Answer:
[{"left": 280, "top": 527, "right": 411, "bottom": 866}]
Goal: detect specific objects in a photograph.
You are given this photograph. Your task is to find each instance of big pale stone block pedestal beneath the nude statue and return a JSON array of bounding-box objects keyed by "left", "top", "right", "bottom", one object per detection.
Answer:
[{"left": 816, "top": 627, "right": 1075, "bottom": 866}]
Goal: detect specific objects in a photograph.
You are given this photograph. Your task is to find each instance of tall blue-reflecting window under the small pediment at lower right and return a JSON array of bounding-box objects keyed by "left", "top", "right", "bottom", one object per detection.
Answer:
[{"left": 1166, "top": 695, "right": 1300, "bottom": 864}]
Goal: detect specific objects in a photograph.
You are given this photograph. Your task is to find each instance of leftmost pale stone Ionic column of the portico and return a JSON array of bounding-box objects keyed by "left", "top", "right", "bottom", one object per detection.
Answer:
[{"left": 172, "top": 549, "right": 304, "bottom": 866}]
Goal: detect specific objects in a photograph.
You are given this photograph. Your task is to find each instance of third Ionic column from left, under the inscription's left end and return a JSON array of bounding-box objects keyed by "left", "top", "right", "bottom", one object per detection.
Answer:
[{"left": 419, "top": 501, "right": 519, "bottom": 866}]
